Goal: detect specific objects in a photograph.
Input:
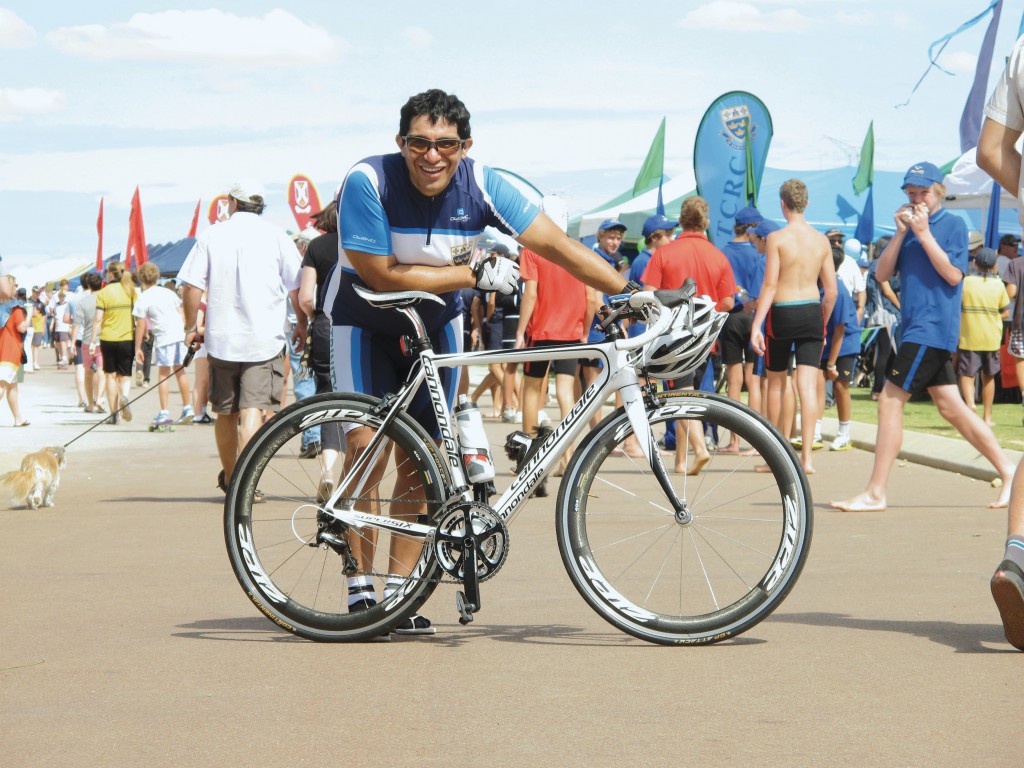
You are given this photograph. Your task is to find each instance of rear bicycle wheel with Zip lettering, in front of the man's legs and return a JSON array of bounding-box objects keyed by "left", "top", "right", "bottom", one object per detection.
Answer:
[{"left": 224, "top": 392, "right": 450, "bottom": 642}]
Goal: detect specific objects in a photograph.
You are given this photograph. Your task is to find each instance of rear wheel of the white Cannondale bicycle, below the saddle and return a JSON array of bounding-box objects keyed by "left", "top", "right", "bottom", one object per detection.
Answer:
[{"left": 224, "top": 393, "right": 449, "bottom": 641}]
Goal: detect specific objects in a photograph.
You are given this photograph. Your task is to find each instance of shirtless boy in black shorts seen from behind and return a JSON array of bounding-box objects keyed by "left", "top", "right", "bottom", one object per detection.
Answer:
[{"left": 751, "top": 178, "right": 837, "bottom": 474}]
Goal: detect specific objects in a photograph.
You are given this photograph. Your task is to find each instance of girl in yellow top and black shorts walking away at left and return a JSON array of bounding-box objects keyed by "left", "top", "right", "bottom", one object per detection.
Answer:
[{"left": 89, "top": 261, "right": 137, "bottom": 424}]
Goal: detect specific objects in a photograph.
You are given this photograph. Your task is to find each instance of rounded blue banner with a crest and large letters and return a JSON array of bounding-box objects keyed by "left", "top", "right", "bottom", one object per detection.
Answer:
[{"left": 693, "top": 91, "right": 772, "bottom": 248}]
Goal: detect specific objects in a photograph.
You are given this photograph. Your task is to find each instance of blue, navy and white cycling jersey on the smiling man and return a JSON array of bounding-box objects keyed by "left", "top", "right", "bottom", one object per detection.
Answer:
[{"left": 331, "top": 153, "right": 540, "bottom": 335}]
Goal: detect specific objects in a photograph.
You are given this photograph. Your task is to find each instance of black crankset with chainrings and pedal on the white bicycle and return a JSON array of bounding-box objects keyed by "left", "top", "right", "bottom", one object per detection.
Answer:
[{"left": 434, "top": 501, "right": 509, "bottom": 625}]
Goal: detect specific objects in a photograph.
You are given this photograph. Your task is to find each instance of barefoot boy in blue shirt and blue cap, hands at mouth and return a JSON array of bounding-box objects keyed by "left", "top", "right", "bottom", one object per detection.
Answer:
[{"left": 831, "top": 163, "right": 1014, "bottom": 512}]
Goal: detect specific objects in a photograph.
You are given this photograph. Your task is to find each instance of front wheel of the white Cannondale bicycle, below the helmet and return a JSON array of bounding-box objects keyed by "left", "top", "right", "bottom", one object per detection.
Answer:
[{"left": 556, "top": 392, "right": 813, "bottom": 645}]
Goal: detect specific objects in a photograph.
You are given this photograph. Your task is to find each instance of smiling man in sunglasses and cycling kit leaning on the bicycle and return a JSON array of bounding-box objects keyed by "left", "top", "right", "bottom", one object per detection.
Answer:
[{"left": 331, "top": 89, "right": 625, "bottom": 634}]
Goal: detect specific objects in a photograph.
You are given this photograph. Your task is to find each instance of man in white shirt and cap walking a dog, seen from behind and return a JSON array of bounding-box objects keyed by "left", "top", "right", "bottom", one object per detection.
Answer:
[{"left": 178, "top": 183, "right": 306, "bottom": 489}]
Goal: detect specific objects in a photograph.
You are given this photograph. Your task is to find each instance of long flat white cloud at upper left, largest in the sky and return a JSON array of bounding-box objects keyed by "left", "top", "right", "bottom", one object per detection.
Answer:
[{"left": 46, "top": 8, "right": 344, "bottom": 66}]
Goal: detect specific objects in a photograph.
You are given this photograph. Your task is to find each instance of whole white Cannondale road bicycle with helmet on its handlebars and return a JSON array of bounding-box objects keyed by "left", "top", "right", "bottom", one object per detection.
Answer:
[{"left": 224, "top": 285, "right": 813, "bottom": 645}]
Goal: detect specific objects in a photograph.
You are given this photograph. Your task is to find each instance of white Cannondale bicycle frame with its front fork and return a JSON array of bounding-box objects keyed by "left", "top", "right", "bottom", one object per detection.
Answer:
[{"left": 324, "top": 296, "right": 685, "bottom": 537}]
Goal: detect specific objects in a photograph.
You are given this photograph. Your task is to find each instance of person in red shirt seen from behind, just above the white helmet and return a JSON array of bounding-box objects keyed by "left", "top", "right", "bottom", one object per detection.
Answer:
[{"left": 643, "top": 196, "right": 736, "bottom": 475}]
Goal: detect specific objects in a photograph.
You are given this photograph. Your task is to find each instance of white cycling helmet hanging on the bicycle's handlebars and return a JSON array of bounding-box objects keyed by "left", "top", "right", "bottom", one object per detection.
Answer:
[{"left": 638, "top": 296, "right": 728, "bottom": 379}]
